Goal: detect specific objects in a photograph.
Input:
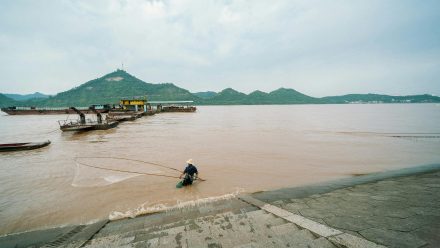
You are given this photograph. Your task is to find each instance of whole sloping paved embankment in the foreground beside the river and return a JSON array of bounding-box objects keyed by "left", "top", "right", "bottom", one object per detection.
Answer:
[{"left": 0, "top": 165, "right": 440, "bottom": 247}]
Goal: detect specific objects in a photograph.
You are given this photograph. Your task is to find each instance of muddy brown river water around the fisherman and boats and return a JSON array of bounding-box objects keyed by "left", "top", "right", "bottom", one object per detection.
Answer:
[{"left": 0, "top": 104, "right": 440, "bottom": 234}]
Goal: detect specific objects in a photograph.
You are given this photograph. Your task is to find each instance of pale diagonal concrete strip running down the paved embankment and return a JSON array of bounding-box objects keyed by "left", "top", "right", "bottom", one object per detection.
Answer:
[{"left": 240, "top": 195, "right": 386, "bottom": 248}]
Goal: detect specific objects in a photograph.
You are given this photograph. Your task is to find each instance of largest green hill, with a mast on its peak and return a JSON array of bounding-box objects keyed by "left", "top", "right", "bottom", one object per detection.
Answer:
[{"left": 22, "top": 70, "right": 199, "bottom": 107}]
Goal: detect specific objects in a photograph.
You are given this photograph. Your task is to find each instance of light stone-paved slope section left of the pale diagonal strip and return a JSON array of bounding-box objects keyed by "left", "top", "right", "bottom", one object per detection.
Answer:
[{"left": 85, "top": 207, "right": 334, "bottom": 248}]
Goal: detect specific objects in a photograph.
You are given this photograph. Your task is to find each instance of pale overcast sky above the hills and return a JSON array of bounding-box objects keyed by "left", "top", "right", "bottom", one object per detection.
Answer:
[{"left": 0, "top": 0, "right": 440, "bottom": 96}]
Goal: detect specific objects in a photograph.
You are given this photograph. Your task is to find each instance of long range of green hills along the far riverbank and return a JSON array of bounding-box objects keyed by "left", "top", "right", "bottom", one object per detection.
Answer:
[{"left": 0, "top": 70, "right": 440, "bottom": 107}]
